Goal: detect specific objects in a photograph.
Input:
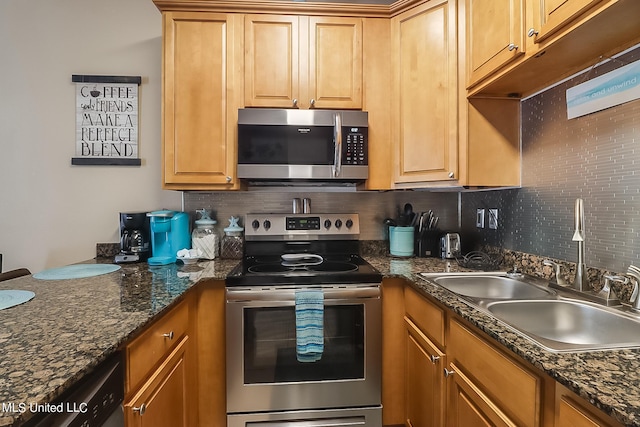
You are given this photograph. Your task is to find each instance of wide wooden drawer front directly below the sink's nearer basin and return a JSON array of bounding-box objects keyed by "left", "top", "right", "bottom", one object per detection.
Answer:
[{"left": 447, "top": 319, "right": 543, "bottom": 426}]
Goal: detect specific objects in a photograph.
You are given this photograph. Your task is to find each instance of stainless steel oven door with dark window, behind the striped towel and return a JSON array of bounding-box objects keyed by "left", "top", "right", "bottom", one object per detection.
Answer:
[{"left": 226, "top": 284, "right": 382, "bottom": 413}]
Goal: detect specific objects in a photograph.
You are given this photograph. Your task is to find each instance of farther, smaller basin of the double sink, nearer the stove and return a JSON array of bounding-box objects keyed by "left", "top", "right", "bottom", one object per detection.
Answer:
[{"left": 425, "top": 274, "right": 554, "bottom": 300}]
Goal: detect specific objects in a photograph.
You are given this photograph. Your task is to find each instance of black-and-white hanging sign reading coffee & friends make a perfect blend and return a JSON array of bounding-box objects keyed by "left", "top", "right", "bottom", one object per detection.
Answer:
[{"left": 71, "top": 74, "right": 142, "bottom": 166}]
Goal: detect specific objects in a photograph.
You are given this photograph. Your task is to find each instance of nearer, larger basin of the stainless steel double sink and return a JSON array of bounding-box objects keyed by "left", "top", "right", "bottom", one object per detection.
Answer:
[{"left": 486, "top": 299, "right": 640, "bottom": 352}]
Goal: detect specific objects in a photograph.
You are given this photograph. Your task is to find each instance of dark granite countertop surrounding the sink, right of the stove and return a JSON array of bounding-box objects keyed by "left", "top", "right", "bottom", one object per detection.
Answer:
[{"left": 365, "top": 256, "right": 640, "bottom": 427}]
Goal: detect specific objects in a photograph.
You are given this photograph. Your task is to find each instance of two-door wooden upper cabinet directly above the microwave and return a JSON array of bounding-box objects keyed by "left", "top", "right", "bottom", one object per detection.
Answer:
[{"left": 244, "top": 15, "right": 362, "bottom": 109}]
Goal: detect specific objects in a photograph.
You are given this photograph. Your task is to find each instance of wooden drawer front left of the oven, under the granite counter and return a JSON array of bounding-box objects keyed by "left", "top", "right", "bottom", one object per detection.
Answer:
[{"left": 126, "top": 300, "right": 189, "bottom": 392}]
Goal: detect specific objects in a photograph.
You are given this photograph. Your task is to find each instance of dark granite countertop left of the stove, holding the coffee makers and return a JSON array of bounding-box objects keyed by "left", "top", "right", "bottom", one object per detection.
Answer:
[{"left": 0, "top": 258, "right": 238, "bottom": 426}]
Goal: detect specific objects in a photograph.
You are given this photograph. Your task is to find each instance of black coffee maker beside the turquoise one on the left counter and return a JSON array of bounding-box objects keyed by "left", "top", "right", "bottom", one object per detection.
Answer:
[{"left": 115, "top": 212, "right": 151, "bottom": 263}]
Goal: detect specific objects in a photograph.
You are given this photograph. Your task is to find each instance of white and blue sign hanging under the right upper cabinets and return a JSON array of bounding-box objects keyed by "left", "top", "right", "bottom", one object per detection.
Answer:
[{"left": 567, "top": 61, "right": 640, "bottom": 119}]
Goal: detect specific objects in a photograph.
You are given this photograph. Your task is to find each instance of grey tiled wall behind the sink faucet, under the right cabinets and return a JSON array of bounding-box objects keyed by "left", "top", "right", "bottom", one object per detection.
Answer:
[{"left": 461, "top": 48, "right": 640, "bottom": 272}]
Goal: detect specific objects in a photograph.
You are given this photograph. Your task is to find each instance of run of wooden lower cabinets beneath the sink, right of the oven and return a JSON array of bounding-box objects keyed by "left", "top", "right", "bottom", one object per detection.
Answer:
[{"left": 390, "top": 279, "right": 621, "bottom": 427}]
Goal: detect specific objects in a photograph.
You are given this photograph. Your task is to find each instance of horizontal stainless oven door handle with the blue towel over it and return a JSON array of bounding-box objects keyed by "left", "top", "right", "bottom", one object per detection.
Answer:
[{"left": 227, "top": 286, "right": 380, "bottom": 302}]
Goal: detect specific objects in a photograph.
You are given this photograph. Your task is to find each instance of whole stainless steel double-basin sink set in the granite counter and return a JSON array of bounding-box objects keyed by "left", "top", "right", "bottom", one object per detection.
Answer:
[{"left": 421, "top": 272, "right": 640, "bottom": 352}]
